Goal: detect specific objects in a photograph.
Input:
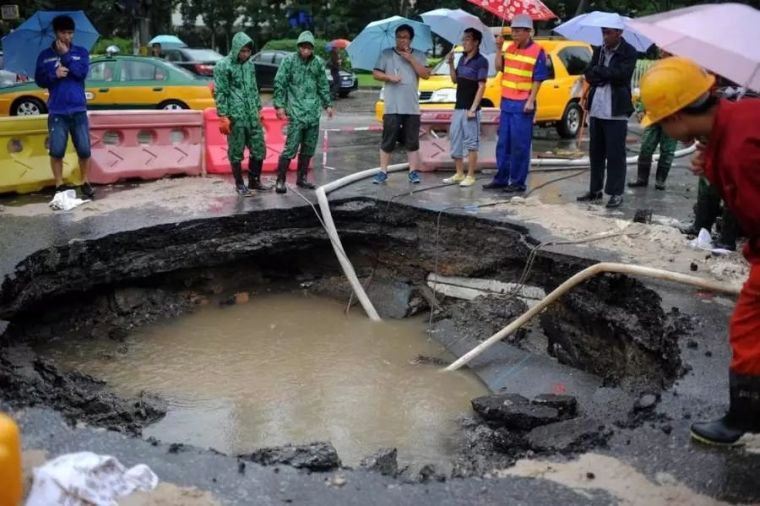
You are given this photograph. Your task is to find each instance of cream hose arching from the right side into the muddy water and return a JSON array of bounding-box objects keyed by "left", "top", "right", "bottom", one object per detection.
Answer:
[{"left": 443, "top": 262, "right": 739, "bottom": 371}]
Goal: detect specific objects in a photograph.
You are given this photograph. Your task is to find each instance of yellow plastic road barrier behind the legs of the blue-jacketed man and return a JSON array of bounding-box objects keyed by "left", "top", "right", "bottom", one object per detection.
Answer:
[{"left": 0, "top": 115, "right": 80, "bottom": 193}]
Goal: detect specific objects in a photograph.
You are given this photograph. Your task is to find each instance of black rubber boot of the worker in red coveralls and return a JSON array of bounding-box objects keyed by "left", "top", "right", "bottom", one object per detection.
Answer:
[{"left": 691, "top": 373, "right": 760, "bottom": 446}]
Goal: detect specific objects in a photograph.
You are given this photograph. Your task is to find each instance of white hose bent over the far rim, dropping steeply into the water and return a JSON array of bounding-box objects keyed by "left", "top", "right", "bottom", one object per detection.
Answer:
[{"left": 316, "top": 163, "right": 409, "bottom": 322}]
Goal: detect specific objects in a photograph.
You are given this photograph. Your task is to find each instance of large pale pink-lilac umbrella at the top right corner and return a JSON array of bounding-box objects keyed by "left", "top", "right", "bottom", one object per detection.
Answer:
[{"left": 630, "top": 4, "right": 760, "bottom": 91}]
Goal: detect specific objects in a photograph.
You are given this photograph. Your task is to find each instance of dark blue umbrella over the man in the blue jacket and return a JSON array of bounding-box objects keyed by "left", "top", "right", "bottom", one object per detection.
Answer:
[{"left": 3, "top": 11, "right": 100, "bottom": 76}]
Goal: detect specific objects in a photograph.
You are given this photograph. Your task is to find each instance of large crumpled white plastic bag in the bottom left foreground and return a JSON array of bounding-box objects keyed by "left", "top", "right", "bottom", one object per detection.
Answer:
[{"left": 26, "top": 452, "right": 158, "bottom": 506}]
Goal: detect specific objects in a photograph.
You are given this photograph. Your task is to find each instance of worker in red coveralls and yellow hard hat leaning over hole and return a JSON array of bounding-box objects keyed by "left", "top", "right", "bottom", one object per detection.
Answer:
[{"left": 640, "top": 57, "right": 760, "bottom": 445}]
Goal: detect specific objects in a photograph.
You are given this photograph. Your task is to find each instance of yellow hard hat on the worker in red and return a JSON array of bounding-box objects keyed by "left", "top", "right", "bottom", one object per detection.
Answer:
[{"left": 639, "top": 56, "right": 715, "bottom": 127}]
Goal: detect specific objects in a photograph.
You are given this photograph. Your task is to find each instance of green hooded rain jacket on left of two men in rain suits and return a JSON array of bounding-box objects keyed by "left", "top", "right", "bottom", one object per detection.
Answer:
[{"left": 214, "top": 32, "right": 261, "bottom": 124}]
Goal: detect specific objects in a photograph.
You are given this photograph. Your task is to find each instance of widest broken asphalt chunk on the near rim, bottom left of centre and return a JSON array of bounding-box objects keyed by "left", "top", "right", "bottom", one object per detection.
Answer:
[{"left": 239, "top": 441, "right": 341, "bottom": 472}]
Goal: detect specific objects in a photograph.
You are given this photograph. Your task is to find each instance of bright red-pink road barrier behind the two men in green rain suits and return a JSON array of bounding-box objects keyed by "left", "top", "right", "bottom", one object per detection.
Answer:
[{"left": 203, "top": 107, "right": 297, "bottom": 174}]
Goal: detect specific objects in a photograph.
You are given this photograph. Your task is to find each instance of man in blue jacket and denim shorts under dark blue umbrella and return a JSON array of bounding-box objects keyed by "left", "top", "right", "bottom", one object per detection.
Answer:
[{"left": 34, "top": 16, "right": 95, "bottom": 198}]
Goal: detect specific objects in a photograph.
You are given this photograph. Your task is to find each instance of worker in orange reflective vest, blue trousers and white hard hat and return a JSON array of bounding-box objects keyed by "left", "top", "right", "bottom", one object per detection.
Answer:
[{"left": 483, "top": 14, "right": 549, "bottom": 193}]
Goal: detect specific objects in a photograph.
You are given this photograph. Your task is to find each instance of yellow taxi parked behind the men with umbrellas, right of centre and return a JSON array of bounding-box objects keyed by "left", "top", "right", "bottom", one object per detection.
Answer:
[{"left": 375, "top": 38, "right": 592, "bottom": 138}]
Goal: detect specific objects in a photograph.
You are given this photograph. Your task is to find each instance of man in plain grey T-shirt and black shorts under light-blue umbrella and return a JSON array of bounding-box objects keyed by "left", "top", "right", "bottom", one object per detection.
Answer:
[{"left": 372, "top": 24, "right": 430, "bottom": 184}]
